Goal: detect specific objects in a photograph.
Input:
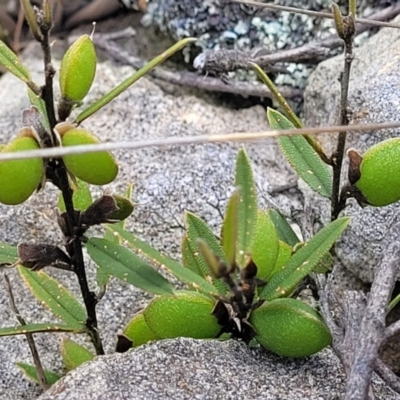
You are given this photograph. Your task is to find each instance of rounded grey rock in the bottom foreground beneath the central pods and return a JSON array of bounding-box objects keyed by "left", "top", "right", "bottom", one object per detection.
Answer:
[{"left": 36, "top": 338, "right": 400, "bottom": 400}]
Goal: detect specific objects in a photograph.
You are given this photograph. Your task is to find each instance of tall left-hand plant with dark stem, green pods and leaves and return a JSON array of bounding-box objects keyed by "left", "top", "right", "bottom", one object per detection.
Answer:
[{"left": 0, "top": 0, "right": 198, "bottom": 387}]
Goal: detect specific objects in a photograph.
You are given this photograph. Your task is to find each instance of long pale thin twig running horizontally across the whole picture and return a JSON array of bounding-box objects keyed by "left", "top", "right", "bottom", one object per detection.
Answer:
[{"left": 0, "top": 122, "right": 400, "bottom": 161}]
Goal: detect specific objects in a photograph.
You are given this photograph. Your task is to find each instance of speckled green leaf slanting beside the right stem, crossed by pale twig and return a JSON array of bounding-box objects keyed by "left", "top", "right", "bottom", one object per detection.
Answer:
[{"left": 267, "top": 108, "right": 332, "bottom": 198}]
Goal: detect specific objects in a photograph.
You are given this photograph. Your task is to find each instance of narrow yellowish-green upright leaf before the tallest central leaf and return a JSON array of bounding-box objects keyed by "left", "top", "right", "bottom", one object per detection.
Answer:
[{"left": 221, "top": 190, "right": 240, "bottom": 266}]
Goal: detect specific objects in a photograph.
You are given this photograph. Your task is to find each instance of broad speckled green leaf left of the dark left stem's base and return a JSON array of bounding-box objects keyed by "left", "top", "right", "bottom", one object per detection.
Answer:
[{"left": 18, "top": 265, "right": 87, "bottom": 330}]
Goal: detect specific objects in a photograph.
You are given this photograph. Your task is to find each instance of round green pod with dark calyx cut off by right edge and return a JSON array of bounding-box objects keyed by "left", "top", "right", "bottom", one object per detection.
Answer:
[{"left": 348, "top": 138, "right": 400, "bottom": 207}]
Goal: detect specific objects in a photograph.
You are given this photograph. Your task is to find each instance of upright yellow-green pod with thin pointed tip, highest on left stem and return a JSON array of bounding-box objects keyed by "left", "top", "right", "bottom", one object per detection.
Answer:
[{"left": 60, "top": 35, "right": 96, "bottom": 102}]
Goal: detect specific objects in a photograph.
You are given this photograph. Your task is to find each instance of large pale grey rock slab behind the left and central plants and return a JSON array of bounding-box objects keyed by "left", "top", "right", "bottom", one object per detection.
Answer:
[{"left": 0, "top": 43, "right": 300, "bottom": 400}]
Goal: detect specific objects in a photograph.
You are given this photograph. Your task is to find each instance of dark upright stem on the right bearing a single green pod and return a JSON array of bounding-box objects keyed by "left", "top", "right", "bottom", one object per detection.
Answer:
[{"left": 331, "top": 14, "right": 355, "bottom": 221}]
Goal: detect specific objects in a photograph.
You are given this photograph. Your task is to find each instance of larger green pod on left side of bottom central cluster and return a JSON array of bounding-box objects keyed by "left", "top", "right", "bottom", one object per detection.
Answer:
[{"left": 143, "top": 290, "right": 221, "bottom": 339}]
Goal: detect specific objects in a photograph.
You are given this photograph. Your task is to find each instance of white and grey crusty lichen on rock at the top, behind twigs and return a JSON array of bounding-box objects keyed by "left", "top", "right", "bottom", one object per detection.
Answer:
[{"left": 142, "top": 0, "right": 388, "bottom": 87}]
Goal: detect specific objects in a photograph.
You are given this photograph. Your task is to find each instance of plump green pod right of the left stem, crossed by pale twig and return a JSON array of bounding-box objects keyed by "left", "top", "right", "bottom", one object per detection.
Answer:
[{"left": 61, "top": 129, "right": 118, "bottom": 185}]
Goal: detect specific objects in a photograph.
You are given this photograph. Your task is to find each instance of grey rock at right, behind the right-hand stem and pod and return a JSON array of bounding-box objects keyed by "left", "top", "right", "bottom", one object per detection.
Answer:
[{"left": 305, "top": 17, "right": 400, "bottom": 282}]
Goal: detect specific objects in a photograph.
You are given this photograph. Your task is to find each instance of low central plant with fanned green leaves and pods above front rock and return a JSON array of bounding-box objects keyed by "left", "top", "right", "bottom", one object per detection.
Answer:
[{"left": 98, "top": 150, "right": 348, "bottom": 357}]
